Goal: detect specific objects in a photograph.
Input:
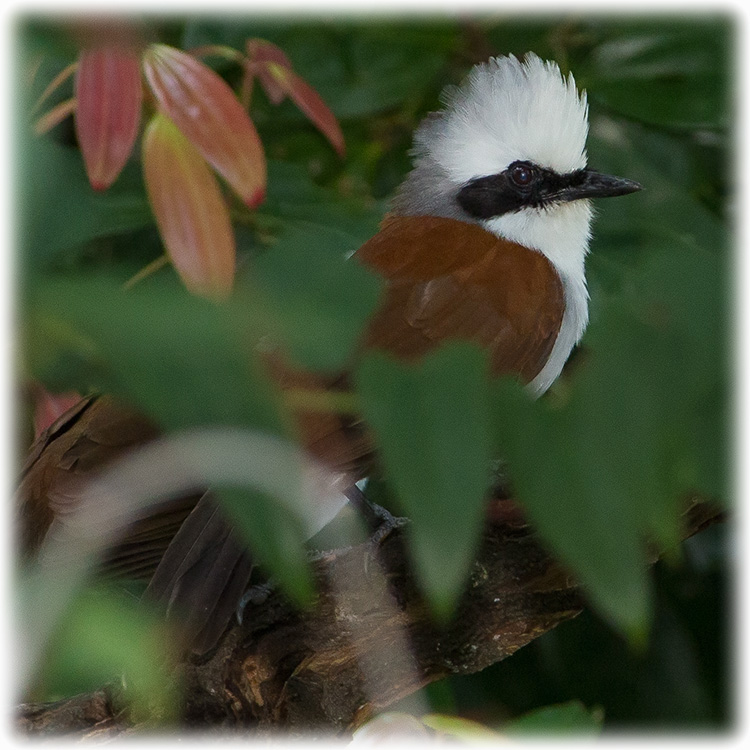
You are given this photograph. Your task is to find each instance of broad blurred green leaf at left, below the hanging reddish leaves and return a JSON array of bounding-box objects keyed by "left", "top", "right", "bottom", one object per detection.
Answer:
[{"left": 24, "top": 275, "right": 281, "bottom": 433}]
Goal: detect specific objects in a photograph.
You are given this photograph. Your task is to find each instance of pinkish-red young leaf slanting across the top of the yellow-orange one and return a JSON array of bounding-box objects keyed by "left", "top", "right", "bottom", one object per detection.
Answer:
[{"left": 143, "top": 44, "right": 266, "bottom": 207}]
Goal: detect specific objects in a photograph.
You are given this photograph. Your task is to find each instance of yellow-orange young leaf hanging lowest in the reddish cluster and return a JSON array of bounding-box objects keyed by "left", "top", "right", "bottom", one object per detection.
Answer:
[{"left": 143, "top": 113, "right": 235, "bottom": 298}]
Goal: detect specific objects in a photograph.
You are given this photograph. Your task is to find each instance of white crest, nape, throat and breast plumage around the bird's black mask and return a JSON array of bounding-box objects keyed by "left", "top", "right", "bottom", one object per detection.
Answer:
[{"left": 393, "top": 53, "right": 592, "bottom": 393}]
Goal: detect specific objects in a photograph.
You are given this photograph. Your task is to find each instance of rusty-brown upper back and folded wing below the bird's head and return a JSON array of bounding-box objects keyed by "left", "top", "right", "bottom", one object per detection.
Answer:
[{"left": 355, "top": 216, "right": 565, "bottom": 382}]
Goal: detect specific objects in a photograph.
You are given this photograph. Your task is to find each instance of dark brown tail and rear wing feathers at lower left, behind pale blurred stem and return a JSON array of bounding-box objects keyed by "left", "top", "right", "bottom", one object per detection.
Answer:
[{"left": 16, "top": 397, "right": 253, "bottom": 653}]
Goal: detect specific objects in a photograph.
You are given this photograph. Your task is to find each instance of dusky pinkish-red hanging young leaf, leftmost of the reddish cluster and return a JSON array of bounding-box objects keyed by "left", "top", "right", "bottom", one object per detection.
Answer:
[{"left": 75, "top": 47, "right": 143, "bottom": 190}]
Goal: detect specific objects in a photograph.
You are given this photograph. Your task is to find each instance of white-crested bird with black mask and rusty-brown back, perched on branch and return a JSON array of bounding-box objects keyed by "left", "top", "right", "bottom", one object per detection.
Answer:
[{"left": 19, "top": 54, "right": 640, "bottom": 652}]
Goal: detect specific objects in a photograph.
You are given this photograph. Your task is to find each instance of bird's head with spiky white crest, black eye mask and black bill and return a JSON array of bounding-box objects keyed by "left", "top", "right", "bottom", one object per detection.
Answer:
[{"left": 394, "top": 54, "right": 640, "bottom": 282}]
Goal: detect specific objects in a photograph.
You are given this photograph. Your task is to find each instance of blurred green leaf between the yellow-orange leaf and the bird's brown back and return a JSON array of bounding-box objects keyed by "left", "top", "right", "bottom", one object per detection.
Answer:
[{"left": 252, "top": 227, "right": 381, "bottom": 371}]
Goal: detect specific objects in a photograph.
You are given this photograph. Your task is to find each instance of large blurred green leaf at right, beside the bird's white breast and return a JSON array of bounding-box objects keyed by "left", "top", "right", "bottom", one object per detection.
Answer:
[{"left": 496, "top": 232, "right": 725, "bottom": 635}]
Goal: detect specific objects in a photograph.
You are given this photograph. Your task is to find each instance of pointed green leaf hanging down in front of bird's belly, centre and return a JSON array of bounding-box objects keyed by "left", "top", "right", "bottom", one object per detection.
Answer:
[{"left": 356, "top": 342, "right": 490, "bottom": 618}]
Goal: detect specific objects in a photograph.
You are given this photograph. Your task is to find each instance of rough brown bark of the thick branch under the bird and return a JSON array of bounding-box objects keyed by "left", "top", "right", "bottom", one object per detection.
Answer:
[{"left": 17, "top": 501, "right": 722, "bottom": 737}]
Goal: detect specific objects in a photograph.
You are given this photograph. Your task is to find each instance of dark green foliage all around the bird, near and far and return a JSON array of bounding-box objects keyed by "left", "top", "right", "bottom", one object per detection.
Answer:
[{"left": 17, "top": 11, "right": 735, "bottom": 731}]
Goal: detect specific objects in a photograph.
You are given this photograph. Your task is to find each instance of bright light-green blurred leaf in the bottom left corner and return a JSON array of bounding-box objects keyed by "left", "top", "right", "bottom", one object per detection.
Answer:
[{"left": 43, "top": 588, "right": 179, "bottom": 720}]
